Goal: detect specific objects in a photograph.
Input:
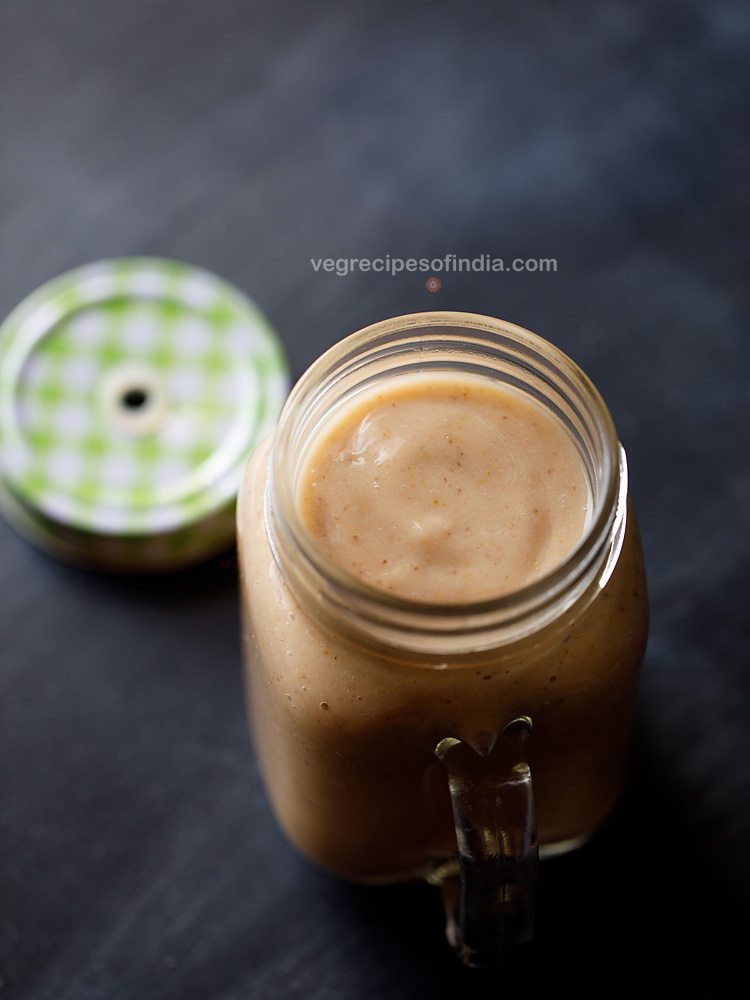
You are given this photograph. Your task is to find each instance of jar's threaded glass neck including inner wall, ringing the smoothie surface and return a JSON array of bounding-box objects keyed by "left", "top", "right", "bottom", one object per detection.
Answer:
[{"left": 266, "top": 312, "right": 624, "bottom": 654}]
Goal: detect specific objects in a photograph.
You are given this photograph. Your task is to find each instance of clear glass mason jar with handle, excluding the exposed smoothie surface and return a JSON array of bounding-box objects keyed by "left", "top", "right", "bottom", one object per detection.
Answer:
[{"left": 238, "top": 312, "right": 647, "bottom": 965}]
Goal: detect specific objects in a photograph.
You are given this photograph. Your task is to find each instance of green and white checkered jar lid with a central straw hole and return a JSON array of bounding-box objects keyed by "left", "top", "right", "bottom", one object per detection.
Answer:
[{"left": 0, "top": 258, "right": 288, "bottom": 570}]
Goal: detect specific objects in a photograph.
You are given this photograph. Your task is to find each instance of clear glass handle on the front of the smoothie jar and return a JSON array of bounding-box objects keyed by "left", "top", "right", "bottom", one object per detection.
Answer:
[{"left": 435, "top": 716, "right": 539, "bottom": 966}]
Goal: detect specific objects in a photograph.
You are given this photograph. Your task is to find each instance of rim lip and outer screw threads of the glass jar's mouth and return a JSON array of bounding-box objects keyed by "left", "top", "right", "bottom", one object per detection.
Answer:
[{"left": 266, "top": 311, "right": 626, "bottom": 648}]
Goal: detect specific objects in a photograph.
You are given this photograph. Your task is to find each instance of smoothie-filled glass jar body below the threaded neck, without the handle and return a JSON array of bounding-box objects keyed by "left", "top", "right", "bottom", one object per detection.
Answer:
[{"left": 238, "top": 442, "right": 647, "bottom": 881}]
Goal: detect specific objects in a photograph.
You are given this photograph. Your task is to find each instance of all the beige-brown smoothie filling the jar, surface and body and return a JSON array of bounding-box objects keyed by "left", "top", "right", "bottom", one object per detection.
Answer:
[{"left": 238, "top": 326, "right": 646, "bottom": 881}]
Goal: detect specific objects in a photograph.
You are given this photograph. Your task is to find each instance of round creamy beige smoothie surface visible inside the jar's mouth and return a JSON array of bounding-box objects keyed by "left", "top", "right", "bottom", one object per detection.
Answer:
[{"left": 298, "top": 374, "right": 589, "bottom": 603}]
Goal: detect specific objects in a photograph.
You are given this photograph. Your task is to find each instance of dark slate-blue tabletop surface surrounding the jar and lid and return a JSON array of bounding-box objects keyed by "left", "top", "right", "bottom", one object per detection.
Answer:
[{"left": 0, "top": 0, "right": 750, "bottom": 1000}]
